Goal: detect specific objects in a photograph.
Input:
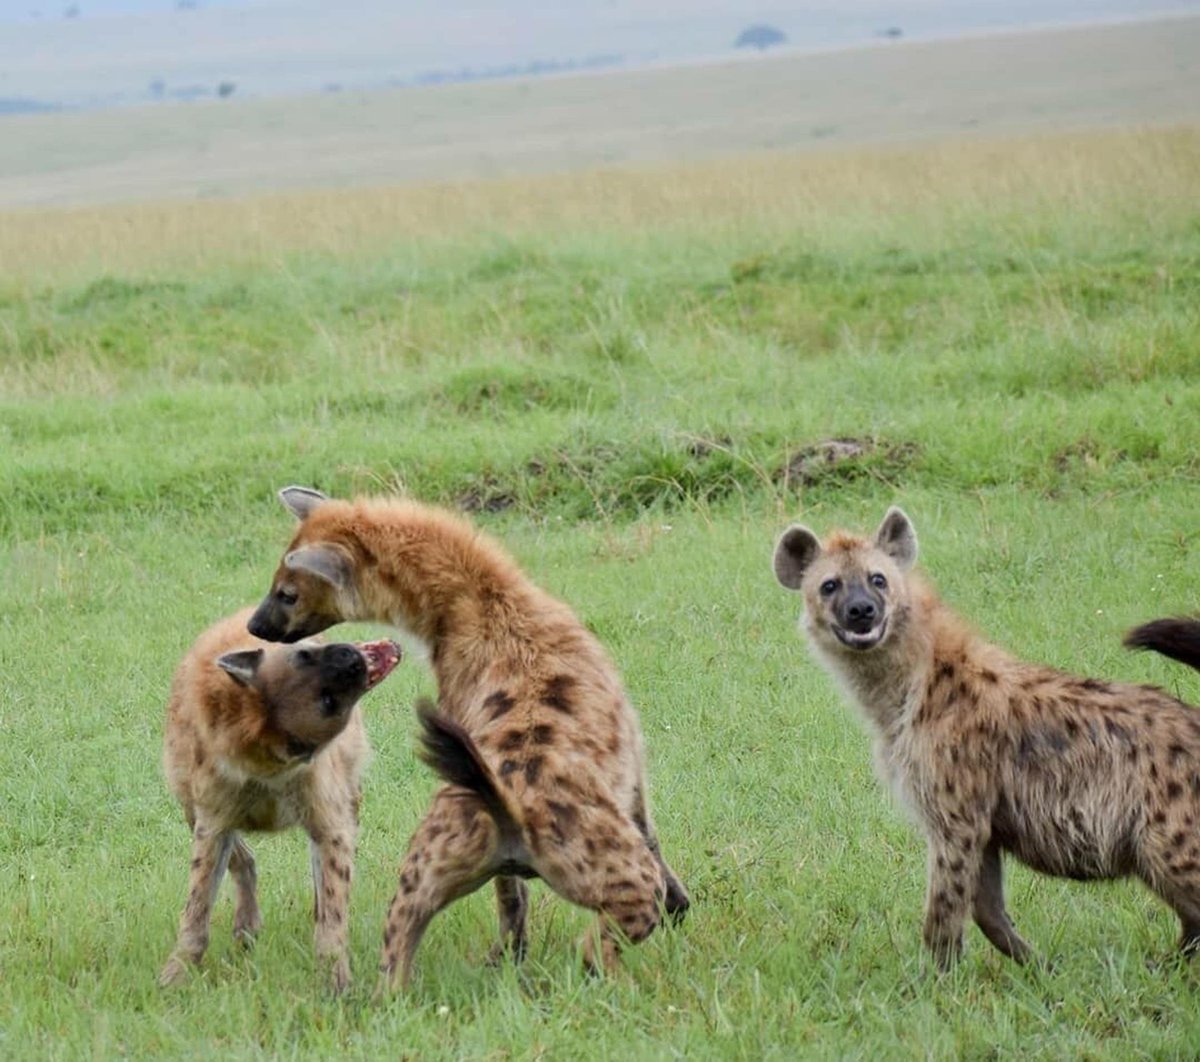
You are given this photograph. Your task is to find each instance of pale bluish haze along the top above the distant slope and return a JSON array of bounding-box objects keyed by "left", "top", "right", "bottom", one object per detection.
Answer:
[{"left": 0, "top": 0, "right": 1200, "bottom": 106}]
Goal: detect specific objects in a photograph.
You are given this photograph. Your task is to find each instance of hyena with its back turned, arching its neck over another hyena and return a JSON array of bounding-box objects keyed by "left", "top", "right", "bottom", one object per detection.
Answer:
[{"left": 250, "top": 487, "right": 688, "bottom": 986}]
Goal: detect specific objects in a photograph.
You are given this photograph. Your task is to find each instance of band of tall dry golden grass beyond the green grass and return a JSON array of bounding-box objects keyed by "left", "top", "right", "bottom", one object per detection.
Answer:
[{"left": 0, "top": 126, "right": 1200, "bottom": 284}]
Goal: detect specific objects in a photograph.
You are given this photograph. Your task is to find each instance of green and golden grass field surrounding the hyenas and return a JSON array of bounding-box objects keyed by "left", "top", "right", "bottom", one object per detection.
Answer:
[{"left": 0, "top": 128, "right": 1200, "bottom": 1058}]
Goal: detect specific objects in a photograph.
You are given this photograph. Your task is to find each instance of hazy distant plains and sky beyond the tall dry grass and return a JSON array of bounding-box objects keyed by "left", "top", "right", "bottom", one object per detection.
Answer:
[{"left": 0, "top": 0, "right": 1200, "bottom": 206}]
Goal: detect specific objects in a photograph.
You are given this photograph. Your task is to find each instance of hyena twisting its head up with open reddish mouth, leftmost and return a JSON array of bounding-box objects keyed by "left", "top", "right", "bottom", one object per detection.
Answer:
[{"left": 160, "top": 608, "right": 400, "bottom": 990}]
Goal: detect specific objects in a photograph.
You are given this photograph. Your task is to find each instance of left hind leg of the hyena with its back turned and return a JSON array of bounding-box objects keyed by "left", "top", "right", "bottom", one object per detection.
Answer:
[{"left": 379, "top": 786, "right": 500, "bottom": 990}]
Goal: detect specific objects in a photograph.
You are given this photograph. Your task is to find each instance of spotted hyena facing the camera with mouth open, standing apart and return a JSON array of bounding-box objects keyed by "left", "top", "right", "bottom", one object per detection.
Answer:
[{"left": 774, "top": 509, "right": 1200, "bottom": 967}]
